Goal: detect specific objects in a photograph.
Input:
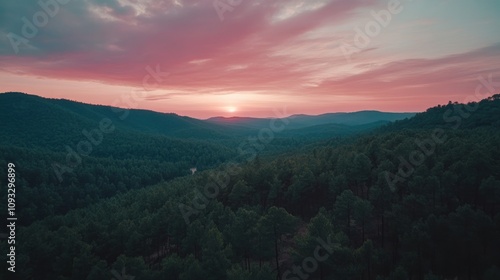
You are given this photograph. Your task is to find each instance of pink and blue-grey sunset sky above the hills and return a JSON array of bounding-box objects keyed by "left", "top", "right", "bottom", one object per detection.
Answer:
[{"left": 0, "top": 0, "right": 500, "bottom": 119}]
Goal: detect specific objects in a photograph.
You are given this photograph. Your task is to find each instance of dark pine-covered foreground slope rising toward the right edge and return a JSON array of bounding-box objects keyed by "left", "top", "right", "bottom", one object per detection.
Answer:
[{"left": 0, "top": 95, "right": 500, "bottom": 280}]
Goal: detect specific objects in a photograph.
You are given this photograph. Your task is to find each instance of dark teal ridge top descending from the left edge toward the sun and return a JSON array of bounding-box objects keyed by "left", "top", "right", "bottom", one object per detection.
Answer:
[{"left": 0, "top": 92, "right": 233, "bottom": 145}]
